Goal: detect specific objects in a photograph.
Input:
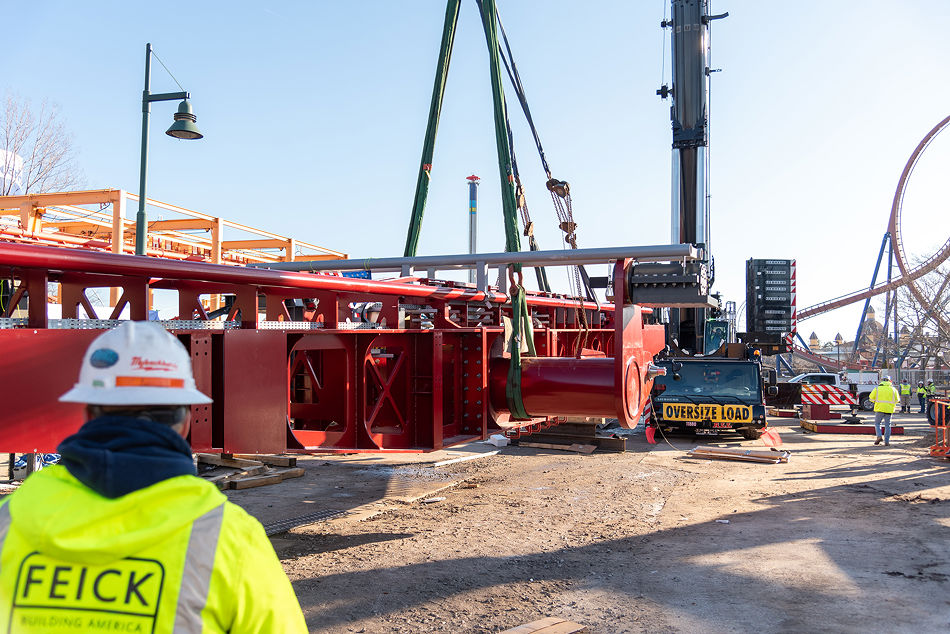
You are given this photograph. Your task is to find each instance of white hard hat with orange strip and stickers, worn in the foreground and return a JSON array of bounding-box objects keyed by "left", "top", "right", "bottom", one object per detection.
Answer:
[{"left": 59, "top": 321, "right": 211, "bottom": 405}]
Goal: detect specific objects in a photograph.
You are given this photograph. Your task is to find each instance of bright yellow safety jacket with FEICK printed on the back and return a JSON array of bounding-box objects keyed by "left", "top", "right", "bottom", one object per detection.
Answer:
[{"left": 0, "top": 465, "right": 307, "bottom": 634}]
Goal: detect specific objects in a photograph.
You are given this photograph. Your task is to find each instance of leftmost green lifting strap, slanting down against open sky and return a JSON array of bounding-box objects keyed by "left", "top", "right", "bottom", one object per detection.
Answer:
[{"left": 403, "top": 0, "right": 461, "bottom": 257}]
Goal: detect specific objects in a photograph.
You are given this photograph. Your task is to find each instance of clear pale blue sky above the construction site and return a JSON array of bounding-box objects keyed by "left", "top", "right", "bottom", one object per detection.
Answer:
[{"left": 0, "top": 0, "right": 950, "bottom": 339}]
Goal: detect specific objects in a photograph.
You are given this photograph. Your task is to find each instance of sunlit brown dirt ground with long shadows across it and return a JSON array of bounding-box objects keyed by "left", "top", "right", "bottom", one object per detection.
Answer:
[{"left": 216, "top": 416, "right": 950, "bottom": 633}]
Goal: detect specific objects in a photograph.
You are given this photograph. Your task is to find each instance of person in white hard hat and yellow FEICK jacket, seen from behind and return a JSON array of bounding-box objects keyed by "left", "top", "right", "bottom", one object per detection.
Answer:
[{"left": 0, "top": 322, "right": 307, "bottom": 634}]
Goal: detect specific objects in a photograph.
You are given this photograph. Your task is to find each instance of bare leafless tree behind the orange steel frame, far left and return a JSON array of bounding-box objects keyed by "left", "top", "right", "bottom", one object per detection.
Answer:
[{"left": 0, "top": 95, "right": 82, "bottom": 196}]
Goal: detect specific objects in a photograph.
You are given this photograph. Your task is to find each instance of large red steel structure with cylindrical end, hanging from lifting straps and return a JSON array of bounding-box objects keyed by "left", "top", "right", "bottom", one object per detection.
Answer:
[{"left": 0, "top": 243, "right": 678, "bottom": 453}]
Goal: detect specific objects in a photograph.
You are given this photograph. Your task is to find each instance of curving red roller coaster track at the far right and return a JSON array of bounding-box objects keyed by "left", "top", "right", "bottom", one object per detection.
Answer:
[{"left": 795, "top": 111, "right": 950, "bottom": 324}]
